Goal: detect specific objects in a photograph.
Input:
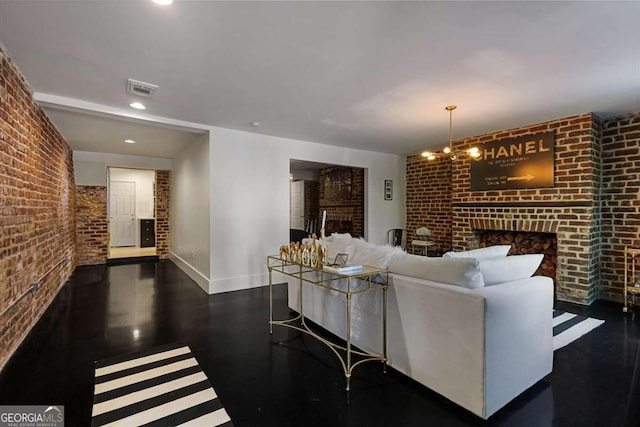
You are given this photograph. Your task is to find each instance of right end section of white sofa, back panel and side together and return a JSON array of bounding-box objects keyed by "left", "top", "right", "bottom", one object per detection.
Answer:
[{"left": 388, "top": 274, "right": 553, "bottom": 419}]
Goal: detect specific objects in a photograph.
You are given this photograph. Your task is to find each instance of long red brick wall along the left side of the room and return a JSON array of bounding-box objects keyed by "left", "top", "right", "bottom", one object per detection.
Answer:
[{"left": 0, "top": 49, "right": 76, "bottom": 369}]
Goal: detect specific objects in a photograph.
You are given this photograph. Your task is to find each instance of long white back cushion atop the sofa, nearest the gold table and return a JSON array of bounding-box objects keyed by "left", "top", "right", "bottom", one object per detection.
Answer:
[{"left": 388, "top": 253, "right": 484, "bottom": 289}]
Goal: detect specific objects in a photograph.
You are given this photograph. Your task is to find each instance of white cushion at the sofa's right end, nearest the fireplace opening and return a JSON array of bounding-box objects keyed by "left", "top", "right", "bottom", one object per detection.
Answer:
[{"left": 480, "top": 254, "right": 544, "bottom": 286}]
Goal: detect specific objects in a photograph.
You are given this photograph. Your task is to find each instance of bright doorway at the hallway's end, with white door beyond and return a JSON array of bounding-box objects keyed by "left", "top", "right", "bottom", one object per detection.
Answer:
[{"left": 107, "top": 167, "right": 157, "bottom": 259}]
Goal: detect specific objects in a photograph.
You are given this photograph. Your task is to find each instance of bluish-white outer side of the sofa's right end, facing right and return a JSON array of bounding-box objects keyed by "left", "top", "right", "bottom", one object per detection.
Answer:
[{"left": 474, "top": 276, "right": 553, "bottom": 416}]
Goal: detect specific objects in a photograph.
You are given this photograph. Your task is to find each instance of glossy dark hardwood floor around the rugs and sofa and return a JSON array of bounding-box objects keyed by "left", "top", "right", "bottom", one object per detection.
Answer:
[{"left": 0, "top": 261, "right": 640, "bottom": 427}]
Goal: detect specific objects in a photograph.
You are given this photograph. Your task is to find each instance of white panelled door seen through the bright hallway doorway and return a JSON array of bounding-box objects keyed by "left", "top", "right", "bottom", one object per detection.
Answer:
[{"left": 109, "top": 181, "right": 136, "bottom": 247}]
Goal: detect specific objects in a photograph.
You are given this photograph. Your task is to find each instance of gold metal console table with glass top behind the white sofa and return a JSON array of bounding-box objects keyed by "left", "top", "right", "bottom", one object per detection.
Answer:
[{"left": 267, "top": 255, "right": 389, "bottom": 391}]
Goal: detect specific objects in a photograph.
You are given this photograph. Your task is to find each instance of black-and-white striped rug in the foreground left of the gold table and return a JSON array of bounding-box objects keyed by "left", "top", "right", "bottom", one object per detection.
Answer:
[{"left": 91, "top": 344, "right": 233, "bottom": 427}]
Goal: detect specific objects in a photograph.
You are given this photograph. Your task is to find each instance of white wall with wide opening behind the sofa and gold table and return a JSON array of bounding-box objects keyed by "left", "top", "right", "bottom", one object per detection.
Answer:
[{"left": 209, "top": 128, "right": 406, "bottom": 293}]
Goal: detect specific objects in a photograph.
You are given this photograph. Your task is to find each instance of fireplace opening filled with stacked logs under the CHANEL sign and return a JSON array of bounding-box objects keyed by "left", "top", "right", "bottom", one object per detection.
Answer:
[{"left": 474, "top": 230, "right": 558, "bottom": 283}]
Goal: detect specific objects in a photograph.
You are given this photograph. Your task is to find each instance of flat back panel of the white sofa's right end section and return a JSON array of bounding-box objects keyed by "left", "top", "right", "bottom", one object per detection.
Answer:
[{"left": 388, "top": 273, "right": 485, "bottom": 416}]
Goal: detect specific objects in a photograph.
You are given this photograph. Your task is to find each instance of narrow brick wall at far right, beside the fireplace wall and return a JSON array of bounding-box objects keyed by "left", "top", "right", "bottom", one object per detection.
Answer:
[{"left": 601, "top": 112, "right": 640, "bottom": 301}]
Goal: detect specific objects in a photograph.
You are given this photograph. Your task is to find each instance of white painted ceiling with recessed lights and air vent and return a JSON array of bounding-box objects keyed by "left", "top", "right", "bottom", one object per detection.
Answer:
[{"left": 0, "top": 0, "right": 640, "bottom": 157}]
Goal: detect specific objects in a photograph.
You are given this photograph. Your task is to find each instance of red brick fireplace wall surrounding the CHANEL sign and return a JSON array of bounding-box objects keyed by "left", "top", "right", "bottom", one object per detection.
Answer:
[{"left": 407, "top": 113, "right": 601, "bottom": 304}]
